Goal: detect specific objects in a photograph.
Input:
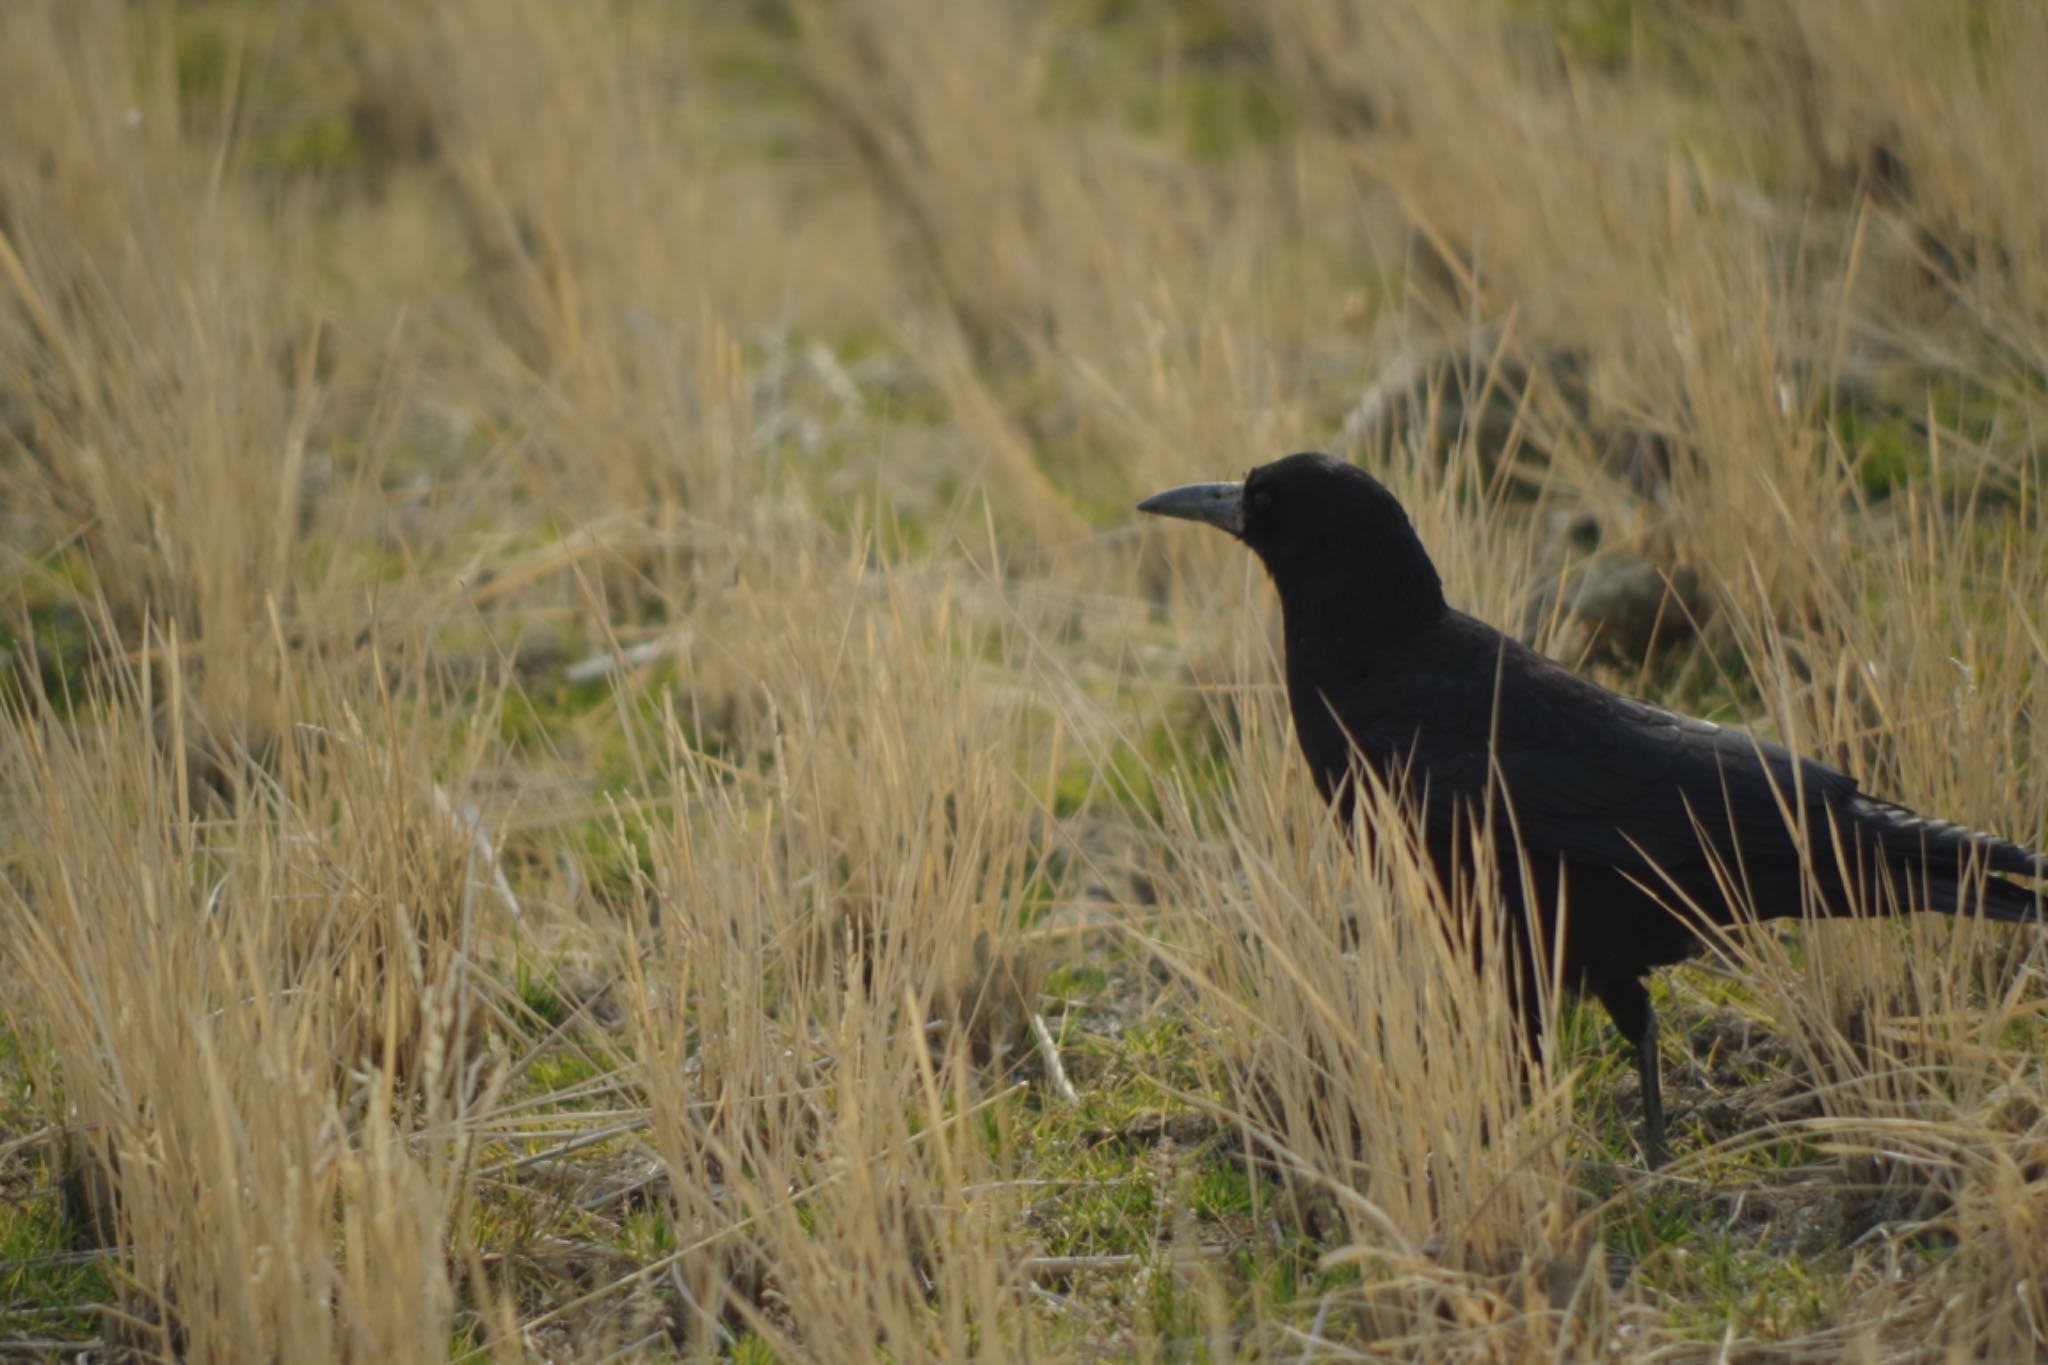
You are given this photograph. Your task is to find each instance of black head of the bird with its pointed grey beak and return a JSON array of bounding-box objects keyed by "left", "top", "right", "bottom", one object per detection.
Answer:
[{"left": 1139, "top": 454, "right": 1444, "bottom": 624}]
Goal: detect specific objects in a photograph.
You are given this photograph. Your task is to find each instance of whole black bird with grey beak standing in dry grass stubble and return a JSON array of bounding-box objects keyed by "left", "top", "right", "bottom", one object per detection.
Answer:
[{"left": 1139, "top": 454, "right": 2048, "bottom": 1164}]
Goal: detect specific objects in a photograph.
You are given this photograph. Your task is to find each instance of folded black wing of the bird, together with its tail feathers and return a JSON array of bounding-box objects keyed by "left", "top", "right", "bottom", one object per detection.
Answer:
[{"left": 1325, "top": 616, "right": 2048, "bottom": 919}]
